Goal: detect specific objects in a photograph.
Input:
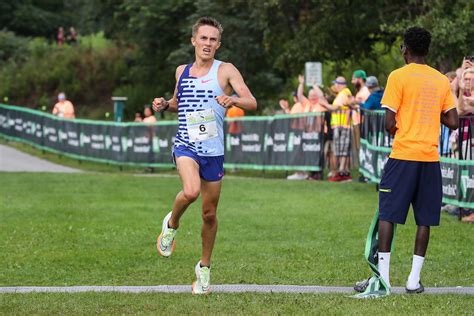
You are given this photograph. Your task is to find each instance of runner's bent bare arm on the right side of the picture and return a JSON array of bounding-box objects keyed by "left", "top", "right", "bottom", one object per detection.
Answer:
[{"left": 216, "top": 63, "right": 257, "bottom": 111}]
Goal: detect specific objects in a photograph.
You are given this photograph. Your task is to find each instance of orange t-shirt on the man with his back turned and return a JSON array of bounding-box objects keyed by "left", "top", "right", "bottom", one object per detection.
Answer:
[{"left": 381, "top": 63, "right": 455, "bottom": 161}]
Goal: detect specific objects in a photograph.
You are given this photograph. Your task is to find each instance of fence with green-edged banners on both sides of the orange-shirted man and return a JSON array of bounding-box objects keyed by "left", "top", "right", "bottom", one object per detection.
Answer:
[{"left": 359, "top": 111, "right": 474, "bottom": 209}]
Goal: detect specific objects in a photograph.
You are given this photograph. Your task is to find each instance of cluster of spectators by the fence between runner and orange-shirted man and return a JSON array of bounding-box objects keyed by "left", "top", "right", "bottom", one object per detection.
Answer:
[{"left": 279, "top": 69, "right": 384, "bottom": 182}]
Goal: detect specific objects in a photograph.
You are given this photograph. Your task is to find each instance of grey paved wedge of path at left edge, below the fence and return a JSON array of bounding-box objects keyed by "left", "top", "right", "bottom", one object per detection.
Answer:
[{"left": 0, "top": 145, "right": 82, "bottom": 172}]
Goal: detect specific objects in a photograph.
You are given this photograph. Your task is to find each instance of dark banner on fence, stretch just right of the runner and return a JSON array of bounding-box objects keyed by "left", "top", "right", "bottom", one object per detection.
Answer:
[{"left": 225, "top": 114, "right": 324, "bottom": 171}]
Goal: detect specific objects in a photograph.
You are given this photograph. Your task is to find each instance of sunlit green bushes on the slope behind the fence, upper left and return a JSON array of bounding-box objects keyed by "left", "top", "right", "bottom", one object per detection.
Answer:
[{"left": 0, "top": 33, "right": 127, "bottom": 113}]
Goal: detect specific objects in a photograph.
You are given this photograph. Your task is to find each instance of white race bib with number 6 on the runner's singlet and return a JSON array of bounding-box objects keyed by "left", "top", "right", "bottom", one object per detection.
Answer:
[{"left": 186, "top": 109, "right": 217, "bottom": 142}]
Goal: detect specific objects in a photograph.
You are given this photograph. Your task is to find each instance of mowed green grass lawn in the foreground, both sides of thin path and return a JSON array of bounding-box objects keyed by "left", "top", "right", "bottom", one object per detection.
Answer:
[{"left": 0, "top": 173, "right": 474, "bottom": 314}]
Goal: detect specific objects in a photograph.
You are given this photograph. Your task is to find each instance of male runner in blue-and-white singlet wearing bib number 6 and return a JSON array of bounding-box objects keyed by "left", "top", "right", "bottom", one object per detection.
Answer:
[{"left": 153, "top": 17, "right": 257, "bottom": 294}]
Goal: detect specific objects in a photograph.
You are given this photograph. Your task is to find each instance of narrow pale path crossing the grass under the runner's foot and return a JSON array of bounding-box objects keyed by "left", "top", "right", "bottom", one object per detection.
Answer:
[{"left": 0, "top": 284, "right": 474, "bottom": 295}]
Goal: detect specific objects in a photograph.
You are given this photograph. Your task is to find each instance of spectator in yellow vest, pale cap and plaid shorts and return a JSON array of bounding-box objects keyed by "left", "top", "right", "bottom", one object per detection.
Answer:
[{"left": 328, "top": 76, "right": 352, "bottom": 182}]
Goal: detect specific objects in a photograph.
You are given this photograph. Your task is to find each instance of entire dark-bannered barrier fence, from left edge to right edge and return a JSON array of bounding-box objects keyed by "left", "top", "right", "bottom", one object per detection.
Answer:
[{"left": 0, "top": 104, "right": 474, "bottom": 209}]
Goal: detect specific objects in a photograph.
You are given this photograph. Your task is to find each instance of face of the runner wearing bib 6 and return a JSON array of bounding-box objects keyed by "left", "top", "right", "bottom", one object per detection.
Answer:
[{"left": 191, "top": 25, "right": 221, "bottom": 60}]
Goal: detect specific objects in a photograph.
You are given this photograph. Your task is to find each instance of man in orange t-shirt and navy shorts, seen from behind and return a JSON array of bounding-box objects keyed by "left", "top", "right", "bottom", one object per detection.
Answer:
[{"left": 362, "top": 27, "right": 458, "bottom": 293}]
